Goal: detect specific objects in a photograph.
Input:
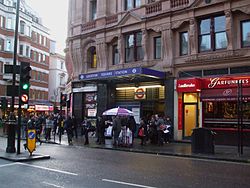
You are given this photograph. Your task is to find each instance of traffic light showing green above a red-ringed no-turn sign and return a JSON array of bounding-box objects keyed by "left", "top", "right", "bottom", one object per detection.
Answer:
[{"left": 19, "top": 62, "right": 31, "bottom": 104}]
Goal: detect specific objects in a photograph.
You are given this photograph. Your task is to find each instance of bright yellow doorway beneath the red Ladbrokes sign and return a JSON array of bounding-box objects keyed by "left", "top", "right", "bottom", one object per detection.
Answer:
[{"left": 183, "top": 104, "right": 197, "bottom": 139}]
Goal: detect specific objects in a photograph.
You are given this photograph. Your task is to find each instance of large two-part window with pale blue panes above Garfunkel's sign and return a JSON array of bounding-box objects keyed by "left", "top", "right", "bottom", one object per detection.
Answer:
[{"left": 199, "top": 16, "right": 227, "bottom": 52}]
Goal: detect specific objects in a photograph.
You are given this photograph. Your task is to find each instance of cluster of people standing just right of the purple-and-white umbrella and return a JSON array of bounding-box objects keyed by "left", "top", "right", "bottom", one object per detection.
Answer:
[{"left": 138, "top": 114, "right": 173, "bottom": 146}]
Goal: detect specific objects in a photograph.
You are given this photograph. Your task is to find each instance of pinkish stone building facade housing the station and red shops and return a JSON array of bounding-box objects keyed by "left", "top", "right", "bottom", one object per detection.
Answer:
[{"left": 66, "top": 0, "right": 250, "bottom": 142}]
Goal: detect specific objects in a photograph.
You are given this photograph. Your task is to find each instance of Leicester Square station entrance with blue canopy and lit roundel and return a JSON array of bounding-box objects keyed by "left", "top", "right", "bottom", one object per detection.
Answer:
[{"left": 73, "top": 67, "right": 173, "bottom": 124}]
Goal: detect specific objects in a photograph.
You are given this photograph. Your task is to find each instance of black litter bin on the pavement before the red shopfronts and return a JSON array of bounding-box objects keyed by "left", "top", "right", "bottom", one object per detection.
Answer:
[{"left": 191, "top": 128, "right": 215, "bottom": 154}]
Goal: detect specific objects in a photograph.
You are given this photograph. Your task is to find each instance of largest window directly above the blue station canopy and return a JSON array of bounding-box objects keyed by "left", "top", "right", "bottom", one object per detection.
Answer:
[{"left": 125, "top": 32, "right": 143, "bottom": 62}]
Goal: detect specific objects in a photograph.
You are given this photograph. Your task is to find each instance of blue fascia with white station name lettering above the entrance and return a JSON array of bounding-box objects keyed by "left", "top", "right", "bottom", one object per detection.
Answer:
[{"left": 79, "top": 67, "right": 165, "bottom": 80}]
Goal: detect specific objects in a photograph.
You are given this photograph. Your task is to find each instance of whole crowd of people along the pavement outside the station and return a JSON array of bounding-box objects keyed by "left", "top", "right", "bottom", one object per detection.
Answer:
[{"left": 6, "top": 111, "right": 173, "bottom": 146}]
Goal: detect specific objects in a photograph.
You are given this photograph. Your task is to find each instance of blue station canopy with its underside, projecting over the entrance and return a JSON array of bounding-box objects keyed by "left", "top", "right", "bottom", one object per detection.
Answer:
[{"left": 79, "top": 67, "right": 165, "bottom": 81}]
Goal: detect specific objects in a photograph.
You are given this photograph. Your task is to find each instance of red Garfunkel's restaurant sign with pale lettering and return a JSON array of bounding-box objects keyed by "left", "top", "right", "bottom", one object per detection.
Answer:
[{"left": 202, "top": 76, "right": 250, "bottom": 89}]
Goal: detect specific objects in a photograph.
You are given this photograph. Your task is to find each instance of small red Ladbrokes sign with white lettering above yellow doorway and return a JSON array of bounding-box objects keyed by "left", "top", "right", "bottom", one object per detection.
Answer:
[{"left": 176, "top": 78, "right": 201, "bottom": 92}]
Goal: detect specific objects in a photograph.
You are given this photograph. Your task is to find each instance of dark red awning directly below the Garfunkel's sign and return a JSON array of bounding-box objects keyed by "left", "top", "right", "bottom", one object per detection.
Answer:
[{"left": 201, "top": 87, "right": 250, "bottom": 101}]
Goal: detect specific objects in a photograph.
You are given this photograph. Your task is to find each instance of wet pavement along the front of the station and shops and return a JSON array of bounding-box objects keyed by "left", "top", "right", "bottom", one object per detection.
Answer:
[{"left": 67, "top": 137, "right": 250, "bottom": 163}]
